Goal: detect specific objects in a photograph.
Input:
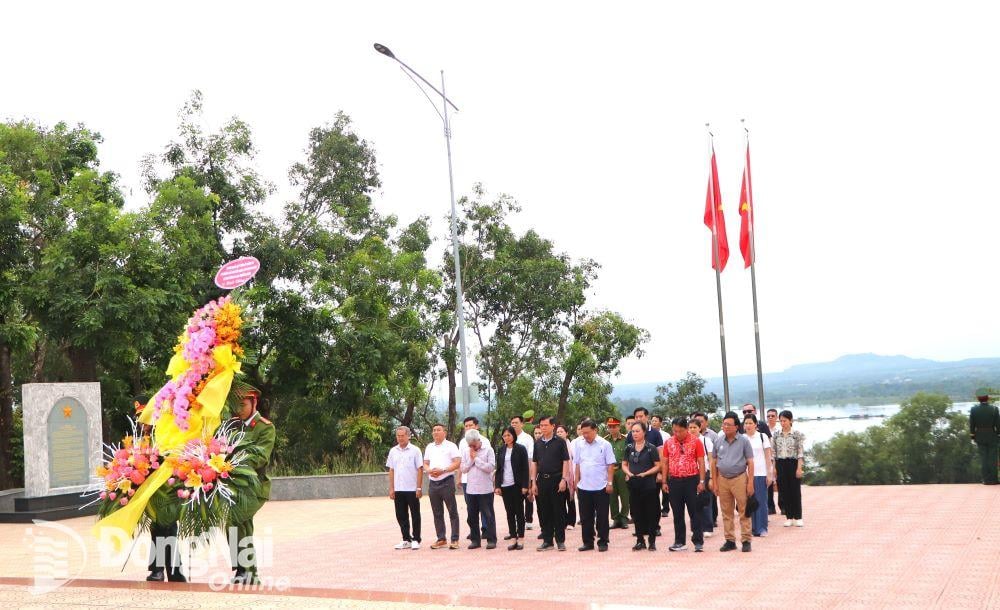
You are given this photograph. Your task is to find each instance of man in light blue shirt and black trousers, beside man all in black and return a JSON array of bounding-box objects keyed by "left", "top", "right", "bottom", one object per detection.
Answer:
[{"left": 573, "top": 419, "right": 617, "bottom": 553}]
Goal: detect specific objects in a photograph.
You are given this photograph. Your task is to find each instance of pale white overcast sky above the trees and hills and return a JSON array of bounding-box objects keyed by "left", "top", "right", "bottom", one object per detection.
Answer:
[{"left": 0, "top": 1, "right": 1000, "bottom": 383}]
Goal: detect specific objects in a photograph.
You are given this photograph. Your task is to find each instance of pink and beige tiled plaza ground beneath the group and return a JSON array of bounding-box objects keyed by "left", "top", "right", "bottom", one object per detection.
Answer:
[{"left": 0, "top": 485, "right": 1000, "bottom": 609}]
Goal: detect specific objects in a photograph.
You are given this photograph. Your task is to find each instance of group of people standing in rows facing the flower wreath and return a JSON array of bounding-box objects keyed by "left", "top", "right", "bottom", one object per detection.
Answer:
[{"left": 386, "top": 404, "right": 805, "bottom": 552}]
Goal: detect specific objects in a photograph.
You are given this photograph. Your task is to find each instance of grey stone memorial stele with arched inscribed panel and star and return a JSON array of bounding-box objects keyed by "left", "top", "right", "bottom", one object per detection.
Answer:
[{"left": 21, "top": 382, "right": 102, "bottom": 498}]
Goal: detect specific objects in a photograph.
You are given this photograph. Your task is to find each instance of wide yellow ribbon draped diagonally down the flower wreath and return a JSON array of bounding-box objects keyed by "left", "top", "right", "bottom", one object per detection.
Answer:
[{"left": 91, "top": 345, "right": 240, "bottom": 551}]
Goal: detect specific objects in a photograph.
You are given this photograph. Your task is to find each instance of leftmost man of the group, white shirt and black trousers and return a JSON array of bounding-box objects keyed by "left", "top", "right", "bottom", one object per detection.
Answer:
[{"left": 385, "top": 426, "right": 424, "bottom": 550}]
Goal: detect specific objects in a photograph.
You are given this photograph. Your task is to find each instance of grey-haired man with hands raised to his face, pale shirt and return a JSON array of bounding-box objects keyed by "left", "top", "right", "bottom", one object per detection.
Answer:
[{"left": 462, "top": 428, "right": 497, "bottom": 549}]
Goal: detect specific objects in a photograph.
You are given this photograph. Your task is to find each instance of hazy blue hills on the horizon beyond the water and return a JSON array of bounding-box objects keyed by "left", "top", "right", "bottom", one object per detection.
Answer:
[{"left": 613, "top": 354, "right": 1000, "bottom": 404}]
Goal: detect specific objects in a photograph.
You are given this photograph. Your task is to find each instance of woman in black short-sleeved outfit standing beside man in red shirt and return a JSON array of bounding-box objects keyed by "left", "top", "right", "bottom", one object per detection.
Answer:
[{"left": 622, "top": 422, "right": 660, "bottom": 551}]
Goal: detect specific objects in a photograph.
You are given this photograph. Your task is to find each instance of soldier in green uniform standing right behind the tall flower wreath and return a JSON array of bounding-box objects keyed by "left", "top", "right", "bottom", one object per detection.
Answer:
[{"left": 226, "top": 390, "right": 275, "bottom": 584}]
